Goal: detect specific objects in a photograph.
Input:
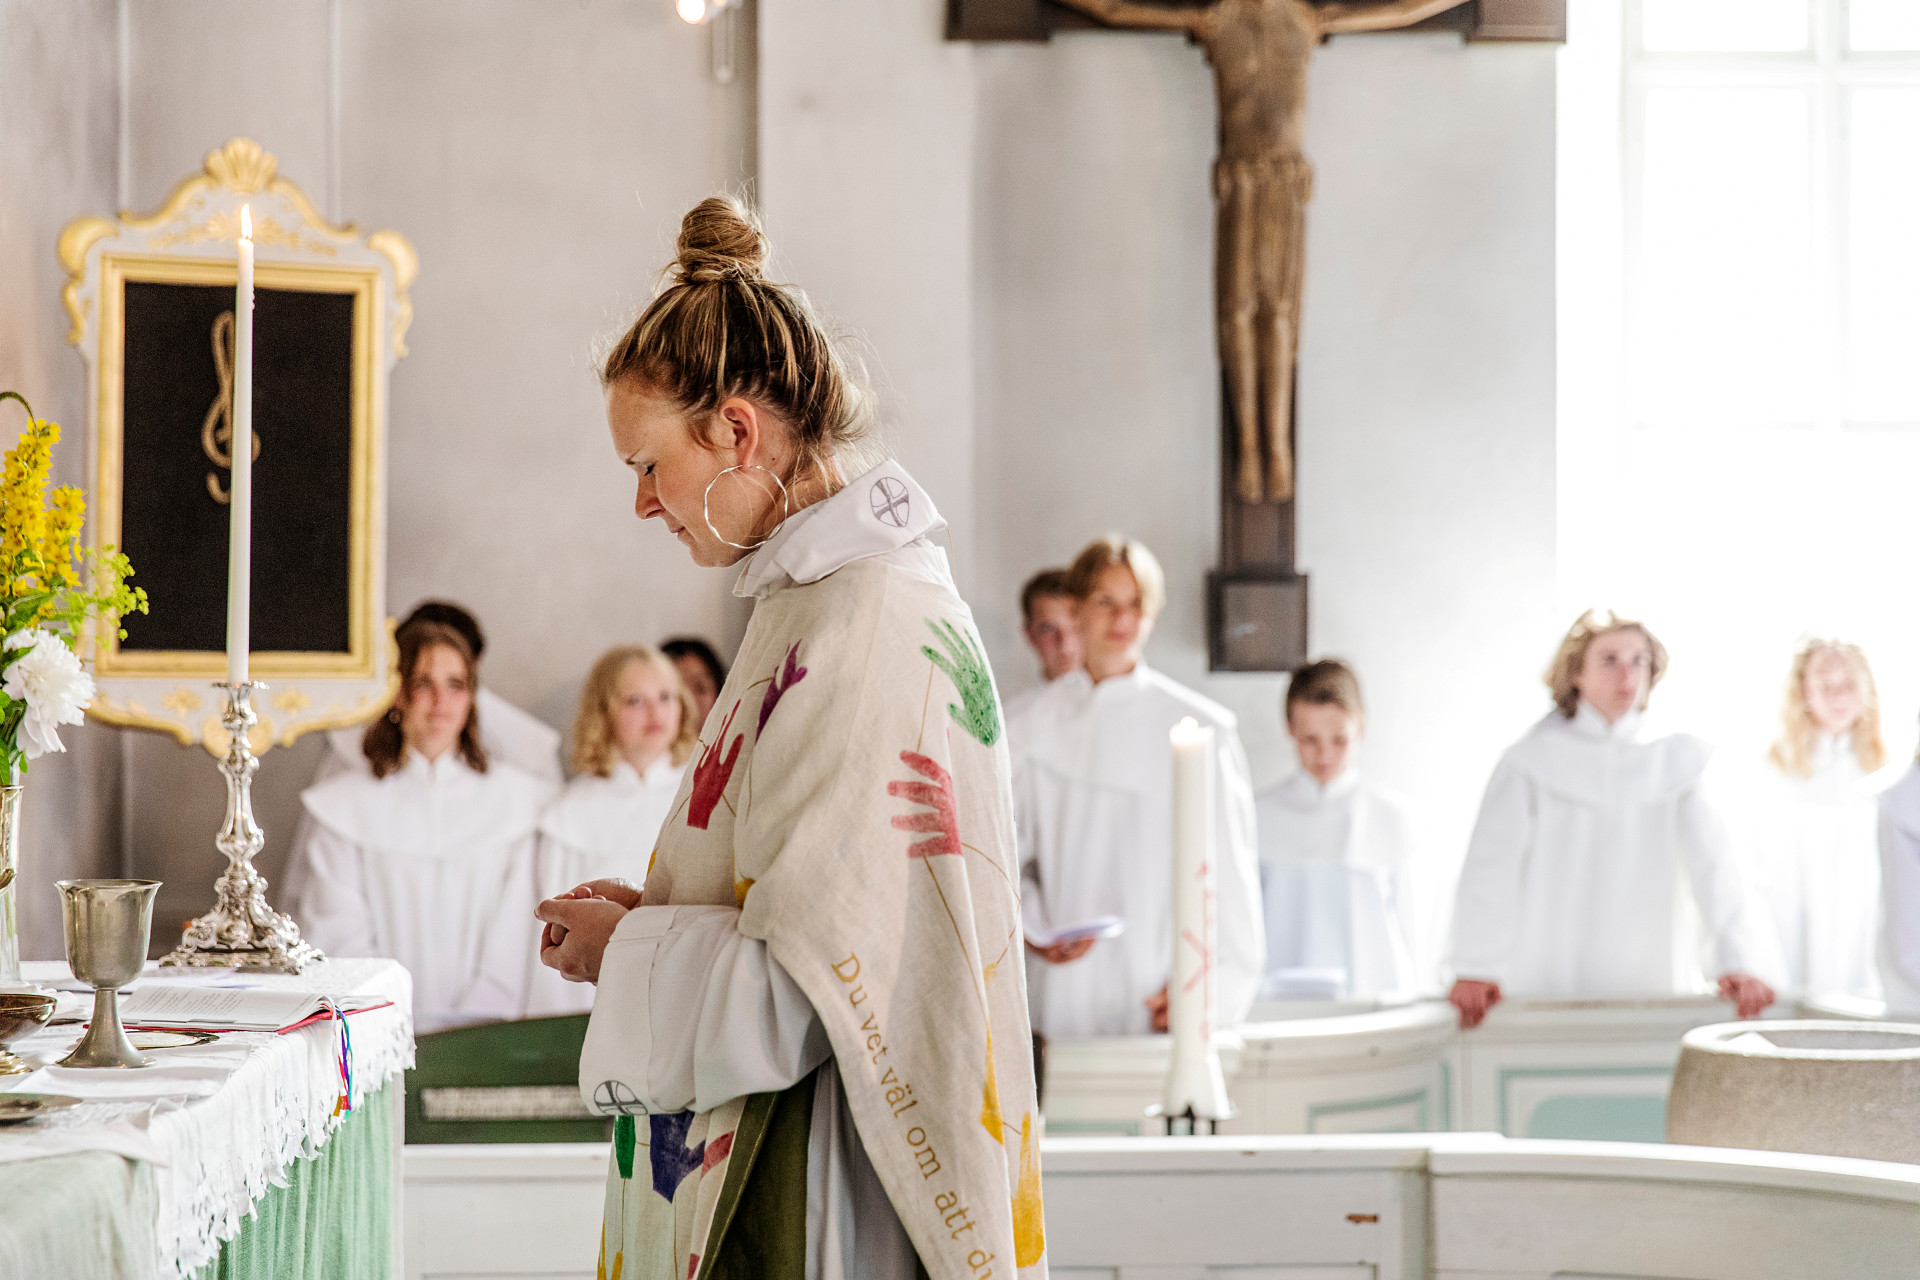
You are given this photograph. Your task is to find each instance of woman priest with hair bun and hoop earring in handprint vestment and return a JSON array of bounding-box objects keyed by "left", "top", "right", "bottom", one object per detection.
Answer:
[{"left": 540, "top": 200, "right": 1046, "bottom": 1280}]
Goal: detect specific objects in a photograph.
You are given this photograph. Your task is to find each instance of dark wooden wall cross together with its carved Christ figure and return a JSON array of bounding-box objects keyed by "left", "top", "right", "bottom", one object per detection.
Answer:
[{"left": 947, "top": 0, "right": 1567, "bottom": 672}]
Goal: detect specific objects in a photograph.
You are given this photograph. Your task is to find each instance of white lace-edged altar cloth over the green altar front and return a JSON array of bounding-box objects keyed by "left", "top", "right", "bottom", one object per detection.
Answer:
[{"left": 0, "top": 960, "right": 413, "bottom": 1278}]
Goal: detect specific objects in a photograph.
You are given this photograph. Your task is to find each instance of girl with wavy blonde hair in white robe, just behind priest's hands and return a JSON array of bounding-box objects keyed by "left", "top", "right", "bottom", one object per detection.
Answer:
[{"left": 526, "top": 645, "right": 699, "bottom": 1017}]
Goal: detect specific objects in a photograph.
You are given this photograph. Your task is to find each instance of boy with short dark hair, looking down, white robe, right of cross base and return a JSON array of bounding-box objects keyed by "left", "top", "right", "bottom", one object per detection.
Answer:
[{"left": 1254, "top": 658, "right": 1423, "bottom": 1000}]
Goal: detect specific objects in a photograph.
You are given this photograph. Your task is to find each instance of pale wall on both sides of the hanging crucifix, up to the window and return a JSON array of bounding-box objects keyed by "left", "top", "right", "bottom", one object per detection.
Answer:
[{"left": 975, "top": 33, "right": 1553, "bottom": 967}]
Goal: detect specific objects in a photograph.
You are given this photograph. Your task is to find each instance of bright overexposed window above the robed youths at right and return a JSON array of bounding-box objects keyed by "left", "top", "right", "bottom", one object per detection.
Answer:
[{"left": 1559, "top": 0, "right": 1920, "bottom": 758}]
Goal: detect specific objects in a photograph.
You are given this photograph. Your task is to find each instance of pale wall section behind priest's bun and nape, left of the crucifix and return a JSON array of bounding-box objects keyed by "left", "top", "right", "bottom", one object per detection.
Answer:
[{"left": 758, "top": 0, "right": 985, "bottom": 597}]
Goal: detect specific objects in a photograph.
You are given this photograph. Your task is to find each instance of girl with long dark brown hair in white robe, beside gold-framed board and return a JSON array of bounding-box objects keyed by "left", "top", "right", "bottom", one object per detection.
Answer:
[{"left": 294, "top": 622, "right": 551, "bottom": 1032}]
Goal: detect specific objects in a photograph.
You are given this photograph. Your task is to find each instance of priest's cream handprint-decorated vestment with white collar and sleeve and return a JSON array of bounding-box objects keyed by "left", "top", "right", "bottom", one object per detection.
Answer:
[{"left": 580, "top": 462, "right": 1046, "bottom": 1280}]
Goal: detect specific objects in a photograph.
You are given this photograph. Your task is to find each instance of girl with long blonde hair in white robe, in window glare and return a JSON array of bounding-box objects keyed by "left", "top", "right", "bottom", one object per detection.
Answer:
[{"left": 1751, "top": 639, "right": 1891, "bottom": 996}]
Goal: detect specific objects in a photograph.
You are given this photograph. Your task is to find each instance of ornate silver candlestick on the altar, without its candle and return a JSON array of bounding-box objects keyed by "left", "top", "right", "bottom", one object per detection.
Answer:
[{"left": 159, "top": 681, "right": 326, "bottom": 973}]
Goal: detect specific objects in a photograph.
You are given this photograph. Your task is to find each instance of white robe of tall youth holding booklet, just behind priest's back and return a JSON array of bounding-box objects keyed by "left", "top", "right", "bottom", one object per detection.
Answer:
[{"left": 1008, "top": 662, "right": 1265, "bottom": 1036}]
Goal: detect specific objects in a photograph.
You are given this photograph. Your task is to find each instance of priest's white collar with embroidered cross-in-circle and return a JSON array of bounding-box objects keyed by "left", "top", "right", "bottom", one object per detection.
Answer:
[{"left": 733, "top": 459, "right": 947, "bottom": 601}]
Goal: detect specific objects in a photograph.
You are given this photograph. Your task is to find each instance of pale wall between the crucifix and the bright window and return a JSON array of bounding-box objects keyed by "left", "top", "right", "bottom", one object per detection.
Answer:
[{"left": 1300, "top": 35, "right": 1567, "bottom": 951}]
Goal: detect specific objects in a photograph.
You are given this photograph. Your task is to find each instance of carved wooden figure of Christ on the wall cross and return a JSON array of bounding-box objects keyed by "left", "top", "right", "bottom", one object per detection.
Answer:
[{"left": 1058, "top": 0, "right": 1465, "bottom": 503}]
